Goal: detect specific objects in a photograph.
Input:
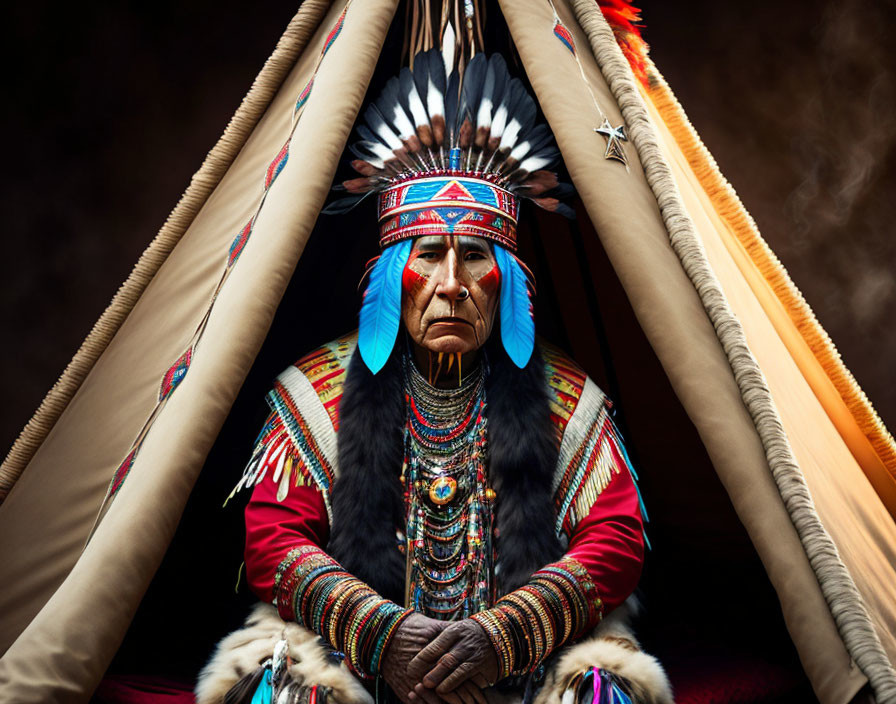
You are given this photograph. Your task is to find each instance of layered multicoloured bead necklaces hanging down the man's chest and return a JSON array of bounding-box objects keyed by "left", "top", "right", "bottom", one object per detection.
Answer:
[{"left": 401, "top": 354, "right": 495, "bottom": 621}]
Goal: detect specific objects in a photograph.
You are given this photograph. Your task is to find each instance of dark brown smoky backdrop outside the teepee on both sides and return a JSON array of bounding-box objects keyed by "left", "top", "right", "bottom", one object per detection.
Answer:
[{"left": 0, "top": 0, "right": 896, "bottom": 447}]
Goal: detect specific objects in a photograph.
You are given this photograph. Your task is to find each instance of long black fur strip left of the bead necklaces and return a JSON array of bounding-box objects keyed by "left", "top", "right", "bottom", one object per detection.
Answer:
[{"left": 328, "top": 350, "right": 405, "bottom": 604}]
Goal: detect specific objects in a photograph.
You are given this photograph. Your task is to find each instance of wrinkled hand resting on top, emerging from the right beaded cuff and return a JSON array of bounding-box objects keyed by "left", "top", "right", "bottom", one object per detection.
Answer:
[{"left": 408, "top": 619, "right": 498, "bottom": 704}]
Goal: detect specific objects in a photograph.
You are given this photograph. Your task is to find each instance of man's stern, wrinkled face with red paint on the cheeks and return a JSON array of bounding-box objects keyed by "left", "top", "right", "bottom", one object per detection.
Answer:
[{"left": 401, "top": 235, "right": 501, "bottom": 354}]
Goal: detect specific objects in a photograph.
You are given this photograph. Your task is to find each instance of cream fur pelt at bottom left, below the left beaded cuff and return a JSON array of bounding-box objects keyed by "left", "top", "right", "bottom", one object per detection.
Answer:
[{"left": 195, "top": 604, "right": 373, "bottom": 704}]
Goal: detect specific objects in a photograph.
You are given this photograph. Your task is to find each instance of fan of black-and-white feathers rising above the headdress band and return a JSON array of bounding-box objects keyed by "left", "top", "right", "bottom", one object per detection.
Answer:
[{"left": 324, "top": 44, "right": 571, "bottom": 213}]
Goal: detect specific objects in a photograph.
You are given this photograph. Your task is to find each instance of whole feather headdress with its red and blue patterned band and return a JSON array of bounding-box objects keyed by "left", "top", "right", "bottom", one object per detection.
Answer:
[{"left": 324, "top": 45, "right": 572, "bottom": 235}]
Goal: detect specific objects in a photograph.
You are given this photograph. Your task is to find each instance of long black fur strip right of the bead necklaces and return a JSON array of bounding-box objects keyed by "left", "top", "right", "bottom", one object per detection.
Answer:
[{"left": 485, "top": 344, "right": 563, "bottom": 594}]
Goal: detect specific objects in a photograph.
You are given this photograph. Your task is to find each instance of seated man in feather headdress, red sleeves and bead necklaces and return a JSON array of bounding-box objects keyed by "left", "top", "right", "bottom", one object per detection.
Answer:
[{"left": 198, "top": 46, "right": 668, "bottom": 704}]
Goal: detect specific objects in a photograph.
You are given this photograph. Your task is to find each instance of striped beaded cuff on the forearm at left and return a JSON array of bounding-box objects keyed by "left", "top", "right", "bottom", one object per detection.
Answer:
[{"left": 274, "top": 545, "right": 411, "bottom": 678}]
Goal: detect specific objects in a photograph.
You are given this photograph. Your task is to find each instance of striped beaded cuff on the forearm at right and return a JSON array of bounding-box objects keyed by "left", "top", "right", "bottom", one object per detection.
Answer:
[{"left": 470, "top": 557, "right": 603, "bottom": 679}]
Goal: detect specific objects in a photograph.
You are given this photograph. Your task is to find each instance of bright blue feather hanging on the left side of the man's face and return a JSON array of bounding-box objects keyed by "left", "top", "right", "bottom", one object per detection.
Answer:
[{"left": 358, "top": 240, "right": 411, "bottom": 374}]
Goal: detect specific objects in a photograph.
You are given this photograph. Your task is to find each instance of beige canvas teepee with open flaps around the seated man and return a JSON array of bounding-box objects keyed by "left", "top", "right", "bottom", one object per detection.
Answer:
[{"left": 0, "top": 0, "right": 896, "bottom": 704}]
